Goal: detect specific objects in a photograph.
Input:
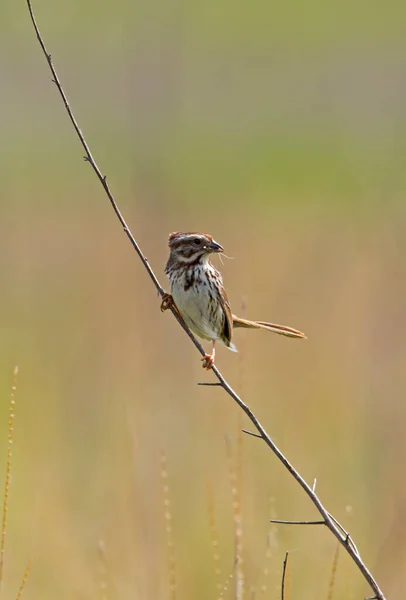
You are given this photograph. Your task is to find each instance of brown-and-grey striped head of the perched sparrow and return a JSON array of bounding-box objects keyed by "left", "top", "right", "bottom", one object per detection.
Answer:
[{"left": 168, "top": 231, "right": 223, "bottom": 264}]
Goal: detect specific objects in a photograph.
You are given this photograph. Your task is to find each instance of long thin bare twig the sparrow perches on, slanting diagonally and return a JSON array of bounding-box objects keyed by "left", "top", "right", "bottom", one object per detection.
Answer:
[{"left": 27, "top": 0, "right": 385, "bottom": 600}]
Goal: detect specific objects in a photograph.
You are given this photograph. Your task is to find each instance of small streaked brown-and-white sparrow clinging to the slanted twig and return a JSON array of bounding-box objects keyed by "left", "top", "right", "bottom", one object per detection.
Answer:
[{"left": 161, "top": 232, "right": 306, "bottom": 369}]
